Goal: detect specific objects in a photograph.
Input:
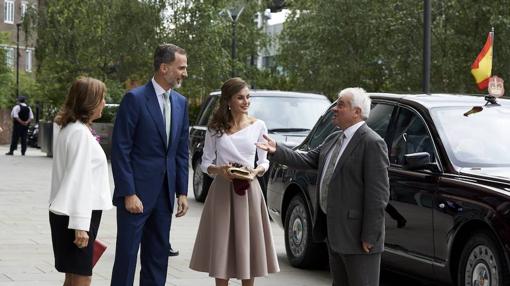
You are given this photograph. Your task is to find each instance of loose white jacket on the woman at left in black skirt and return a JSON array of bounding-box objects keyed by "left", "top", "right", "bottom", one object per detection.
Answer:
[{"left": 49, "top": 121, "right": 113, "bottom": 231}]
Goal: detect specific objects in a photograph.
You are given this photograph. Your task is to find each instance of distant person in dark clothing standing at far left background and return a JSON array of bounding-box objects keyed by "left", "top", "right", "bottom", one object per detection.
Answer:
[{"left": 5, "top": 96, "right": 34, "bottom": 156}]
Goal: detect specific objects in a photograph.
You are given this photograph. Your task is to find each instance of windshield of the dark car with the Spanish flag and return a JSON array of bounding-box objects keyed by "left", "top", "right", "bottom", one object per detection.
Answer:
[{"left": 431, "top": 105, "right": 510, "bottom": 167}]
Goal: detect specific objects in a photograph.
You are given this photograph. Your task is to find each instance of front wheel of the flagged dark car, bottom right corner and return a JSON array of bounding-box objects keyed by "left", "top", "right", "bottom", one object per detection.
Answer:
[{"left": 457, "top": 233, "right": 510, "bottom": 286}]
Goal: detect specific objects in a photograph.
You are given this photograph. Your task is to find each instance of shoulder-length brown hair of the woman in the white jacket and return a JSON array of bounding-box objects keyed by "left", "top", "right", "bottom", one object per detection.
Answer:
[{"left": 55, "top": 77, "right": 106, "bottom": 128}]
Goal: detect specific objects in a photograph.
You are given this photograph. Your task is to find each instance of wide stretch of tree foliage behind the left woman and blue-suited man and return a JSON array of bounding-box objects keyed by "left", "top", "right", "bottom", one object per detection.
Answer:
[{"left": 28, "top": 0, "right": 267, "bottom": 120}]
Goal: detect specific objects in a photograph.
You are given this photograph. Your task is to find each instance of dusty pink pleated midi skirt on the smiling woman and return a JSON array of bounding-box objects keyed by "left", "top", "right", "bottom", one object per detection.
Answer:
[{"left": 190, "top": 176, "right": 280, "bottom": 279}]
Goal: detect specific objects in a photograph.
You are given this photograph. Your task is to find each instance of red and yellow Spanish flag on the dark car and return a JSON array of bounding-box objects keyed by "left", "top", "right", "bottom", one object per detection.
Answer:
[{"left": 471, "top": 32, "right": 494, "bottom": 90}]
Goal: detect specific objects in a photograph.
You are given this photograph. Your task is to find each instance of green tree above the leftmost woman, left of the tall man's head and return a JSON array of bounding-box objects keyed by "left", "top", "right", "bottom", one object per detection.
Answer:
[{"left": 27, "top": 0, "right": 164, "bottom": 113}]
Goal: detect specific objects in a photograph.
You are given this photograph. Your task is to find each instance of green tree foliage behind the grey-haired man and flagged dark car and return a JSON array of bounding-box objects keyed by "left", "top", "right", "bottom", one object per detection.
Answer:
[{"left": 278, "top": 0, "right": 510, "bottom": 96}]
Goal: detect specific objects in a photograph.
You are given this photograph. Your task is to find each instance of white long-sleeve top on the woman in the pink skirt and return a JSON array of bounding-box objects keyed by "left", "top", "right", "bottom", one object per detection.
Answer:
[{"left": 200, "top": 119, "right": 269, "bottom": 177}]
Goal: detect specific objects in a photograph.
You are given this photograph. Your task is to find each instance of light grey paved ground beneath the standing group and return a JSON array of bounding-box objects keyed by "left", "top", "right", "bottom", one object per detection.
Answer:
[{"left": 0, "top": 145, "right": 331, "bottom": 286}]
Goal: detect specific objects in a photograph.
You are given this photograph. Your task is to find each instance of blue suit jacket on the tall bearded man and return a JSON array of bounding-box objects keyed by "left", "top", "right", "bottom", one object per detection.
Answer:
[{"left": 111, "top": 81, "right": 189, "bottom": 210}]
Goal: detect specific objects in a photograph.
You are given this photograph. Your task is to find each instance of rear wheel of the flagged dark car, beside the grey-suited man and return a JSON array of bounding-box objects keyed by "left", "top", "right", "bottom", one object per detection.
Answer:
[{"left": 284, "top": 195, "right": 327, "bottom": 268}]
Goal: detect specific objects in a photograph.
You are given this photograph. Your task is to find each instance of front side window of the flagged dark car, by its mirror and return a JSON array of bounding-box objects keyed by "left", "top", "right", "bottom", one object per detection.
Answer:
[{"left": 390, "top": 108, "right": 435, "bottom": 165}]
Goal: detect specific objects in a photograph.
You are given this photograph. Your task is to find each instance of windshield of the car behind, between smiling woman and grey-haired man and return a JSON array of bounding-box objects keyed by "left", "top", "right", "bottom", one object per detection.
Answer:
[{"left": 249, "top": 96, "right": 330, "bottom": 132}]
